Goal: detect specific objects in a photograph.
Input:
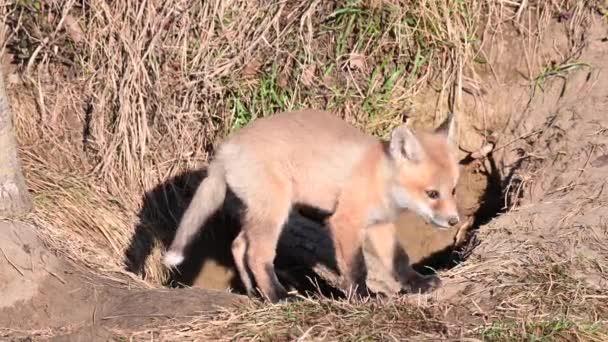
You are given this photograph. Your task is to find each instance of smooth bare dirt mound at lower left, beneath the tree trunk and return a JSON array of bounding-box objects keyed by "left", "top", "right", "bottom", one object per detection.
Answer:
[{"left": 0, "top": 222, "right": 244, "bottom": 341}]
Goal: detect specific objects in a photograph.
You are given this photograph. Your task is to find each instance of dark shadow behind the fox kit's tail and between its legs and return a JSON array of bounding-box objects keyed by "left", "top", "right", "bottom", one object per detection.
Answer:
[{"left": 125, "top": 169, "right": 340, "bottom": 296}]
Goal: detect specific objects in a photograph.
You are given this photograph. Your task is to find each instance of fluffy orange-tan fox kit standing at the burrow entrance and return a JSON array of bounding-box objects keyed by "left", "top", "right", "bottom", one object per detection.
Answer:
[{"left": 164, "top": 110, "right": 459, "bottom": 302}]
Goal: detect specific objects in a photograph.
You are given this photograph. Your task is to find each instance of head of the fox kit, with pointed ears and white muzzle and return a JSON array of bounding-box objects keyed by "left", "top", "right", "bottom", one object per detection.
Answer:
[{"left": 389, "top": 113, "right": 460, "bottom": 228}]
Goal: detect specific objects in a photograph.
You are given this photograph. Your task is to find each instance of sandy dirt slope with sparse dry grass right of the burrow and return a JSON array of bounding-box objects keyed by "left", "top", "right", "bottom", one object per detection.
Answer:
[{"left": 428, "top": 16, "right": 608, "bottom": 340}]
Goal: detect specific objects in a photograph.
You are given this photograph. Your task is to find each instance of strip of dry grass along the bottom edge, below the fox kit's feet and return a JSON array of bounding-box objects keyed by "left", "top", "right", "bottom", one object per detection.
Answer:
[{"left": 114, "top": 264, "right": 608, "bottom": 341}]
